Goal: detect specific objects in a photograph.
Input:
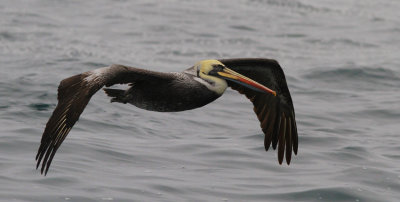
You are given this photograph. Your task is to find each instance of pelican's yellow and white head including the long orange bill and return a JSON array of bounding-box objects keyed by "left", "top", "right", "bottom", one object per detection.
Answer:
[{"left": 195, "top": 60, "right": 276, "bottom": 96}]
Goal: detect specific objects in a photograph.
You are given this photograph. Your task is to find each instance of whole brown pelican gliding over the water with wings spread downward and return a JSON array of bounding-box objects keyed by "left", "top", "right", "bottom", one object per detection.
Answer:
[{"left": 36, "top": 58, "right": 298, "bottom": 175}]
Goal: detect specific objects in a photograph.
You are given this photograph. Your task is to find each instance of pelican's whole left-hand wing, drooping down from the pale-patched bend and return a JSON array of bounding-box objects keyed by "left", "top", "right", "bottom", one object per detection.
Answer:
[{"left": 36, "top": 65, "right": 172, "bottom": 175}]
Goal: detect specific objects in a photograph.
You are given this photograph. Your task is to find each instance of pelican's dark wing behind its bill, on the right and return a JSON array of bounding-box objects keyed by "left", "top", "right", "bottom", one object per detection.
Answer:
[{"left": 219, "top": 58, "right": 298, "bottom": 164}]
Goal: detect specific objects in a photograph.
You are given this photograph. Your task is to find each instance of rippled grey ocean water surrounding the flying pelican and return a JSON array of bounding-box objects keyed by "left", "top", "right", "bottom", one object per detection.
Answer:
[{"left": 0, "top": 0, "right": 400, "bottom": 202}]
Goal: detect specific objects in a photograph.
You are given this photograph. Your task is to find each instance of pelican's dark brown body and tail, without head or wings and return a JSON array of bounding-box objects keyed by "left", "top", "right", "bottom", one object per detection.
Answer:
[{"left": 104, "top": 65, "right": 222, "bottom": 112}]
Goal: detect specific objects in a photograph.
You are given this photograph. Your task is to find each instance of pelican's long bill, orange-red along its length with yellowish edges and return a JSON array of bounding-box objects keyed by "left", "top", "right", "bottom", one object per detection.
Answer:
[{"left": 217, "top": 67, "right": 276, "bottom": 96}]
